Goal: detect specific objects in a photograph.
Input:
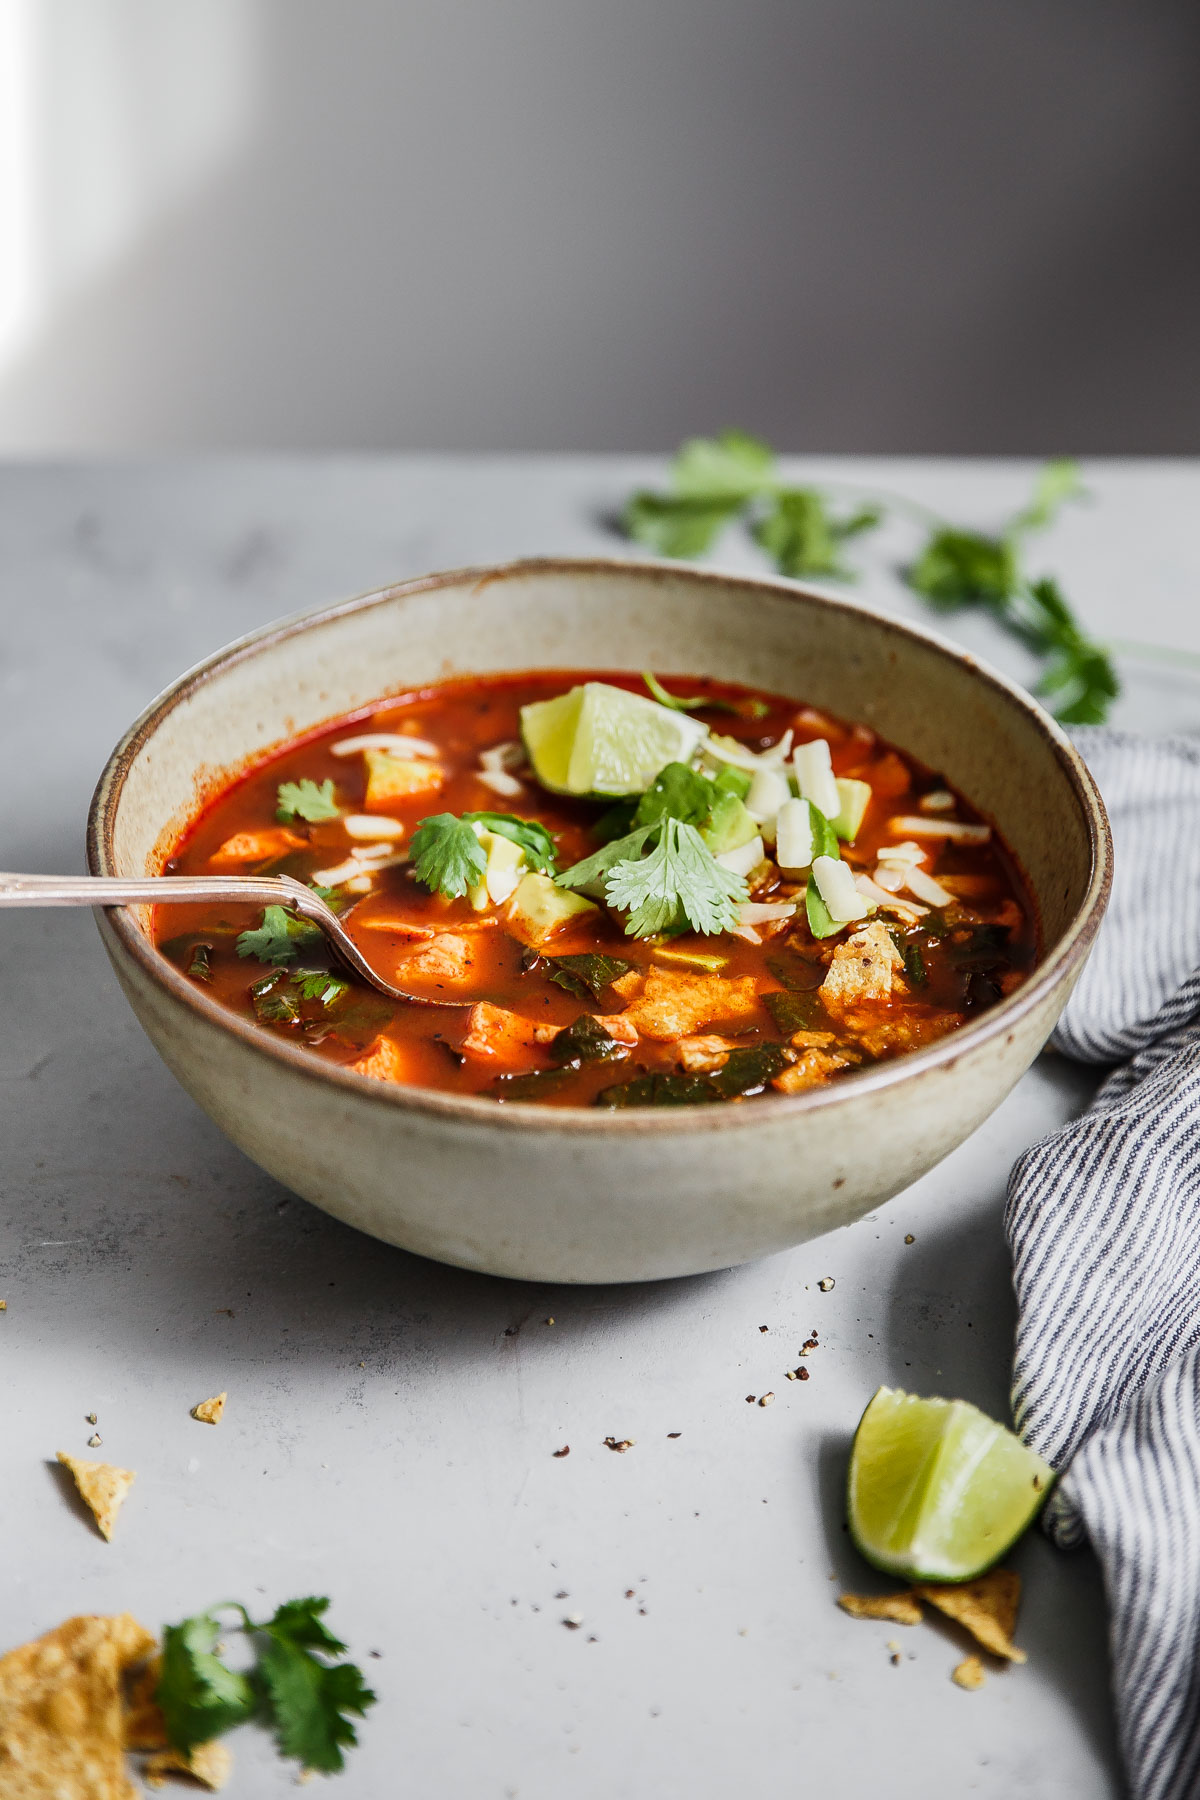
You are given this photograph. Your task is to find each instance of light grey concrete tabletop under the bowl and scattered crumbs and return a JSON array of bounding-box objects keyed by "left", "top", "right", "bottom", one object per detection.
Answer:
[{"left": 0, "top": 459, "right": 1200, "bottom": 1800}]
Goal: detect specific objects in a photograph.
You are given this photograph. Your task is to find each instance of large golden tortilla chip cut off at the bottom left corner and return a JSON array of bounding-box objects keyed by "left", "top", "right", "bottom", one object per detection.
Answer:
[{"left": 0, "top": 1613, "right": 155, "bottom": 1800}]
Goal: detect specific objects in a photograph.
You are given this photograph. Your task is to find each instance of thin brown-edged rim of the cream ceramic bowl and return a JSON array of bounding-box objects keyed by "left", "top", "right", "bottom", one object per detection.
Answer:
[{"left": 86, "top": 556, "right": 1112, "bottom": 1138}]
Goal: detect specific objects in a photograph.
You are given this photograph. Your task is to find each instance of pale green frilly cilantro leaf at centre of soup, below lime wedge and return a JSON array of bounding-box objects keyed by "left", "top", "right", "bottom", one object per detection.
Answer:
[{"left": 604, "top": 817, "right": 748, "bottom": 938}]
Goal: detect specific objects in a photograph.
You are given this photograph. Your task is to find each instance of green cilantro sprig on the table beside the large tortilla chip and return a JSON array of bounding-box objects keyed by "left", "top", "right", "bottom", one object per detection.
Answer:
[{"left": 157, "top": 1597, "right": 376, "bottom": 1775}]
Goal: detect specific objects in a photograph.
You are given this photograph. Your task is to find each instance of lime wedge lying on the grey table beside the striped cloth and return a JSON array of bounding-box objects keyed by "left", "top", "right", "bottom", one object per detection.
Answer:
[{"left": 846, "top": 1388, "right": 1054, "bottom": 1580}]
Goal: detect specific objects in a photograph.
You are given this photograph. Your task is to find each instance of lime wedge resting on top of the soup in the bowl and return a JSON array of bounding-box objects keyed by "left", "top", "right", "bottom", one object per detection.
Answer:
[{"left": 520, "top": 680, "right": 709, "bottom": 794}]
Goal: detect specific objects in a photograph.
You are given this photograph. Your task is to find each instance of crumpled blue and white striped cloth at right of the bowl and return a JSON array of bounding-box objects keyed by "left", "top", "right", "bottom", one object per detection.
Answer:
[{"left": 1006, "top": 729, "right": 1200, "bottom": 1800}]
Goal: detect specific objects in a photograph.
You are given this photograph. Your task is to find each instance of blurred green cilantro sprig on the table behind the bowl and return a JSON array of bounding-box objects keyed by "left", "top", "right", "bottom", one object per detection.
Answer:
[{"left": 624, "top": 432, "right": 1121, "bottom": 725}]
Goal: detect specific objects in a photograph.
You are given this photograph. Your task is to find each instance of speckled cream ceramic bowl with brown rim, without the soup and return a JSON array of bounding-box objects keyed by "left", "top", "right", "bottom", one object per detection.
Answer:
[{"left": 88, "top": 560, "right": 1112, "bottom": 1282}]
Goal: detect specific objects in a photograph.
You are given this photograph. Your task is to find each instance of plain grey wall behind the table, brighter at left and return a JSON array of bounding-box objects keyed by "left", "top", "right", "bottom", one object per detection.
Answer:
[{"left": 0, "top": 0, "right": 1200, "bottom": 454}]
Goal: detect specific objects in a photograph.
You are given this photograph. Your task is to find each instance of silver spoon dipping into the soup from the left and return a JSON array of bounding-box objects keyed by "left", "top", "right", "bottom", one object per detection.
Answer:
[{"left": 0, "top": 875, "right": 471, "bottom": 1006}]
